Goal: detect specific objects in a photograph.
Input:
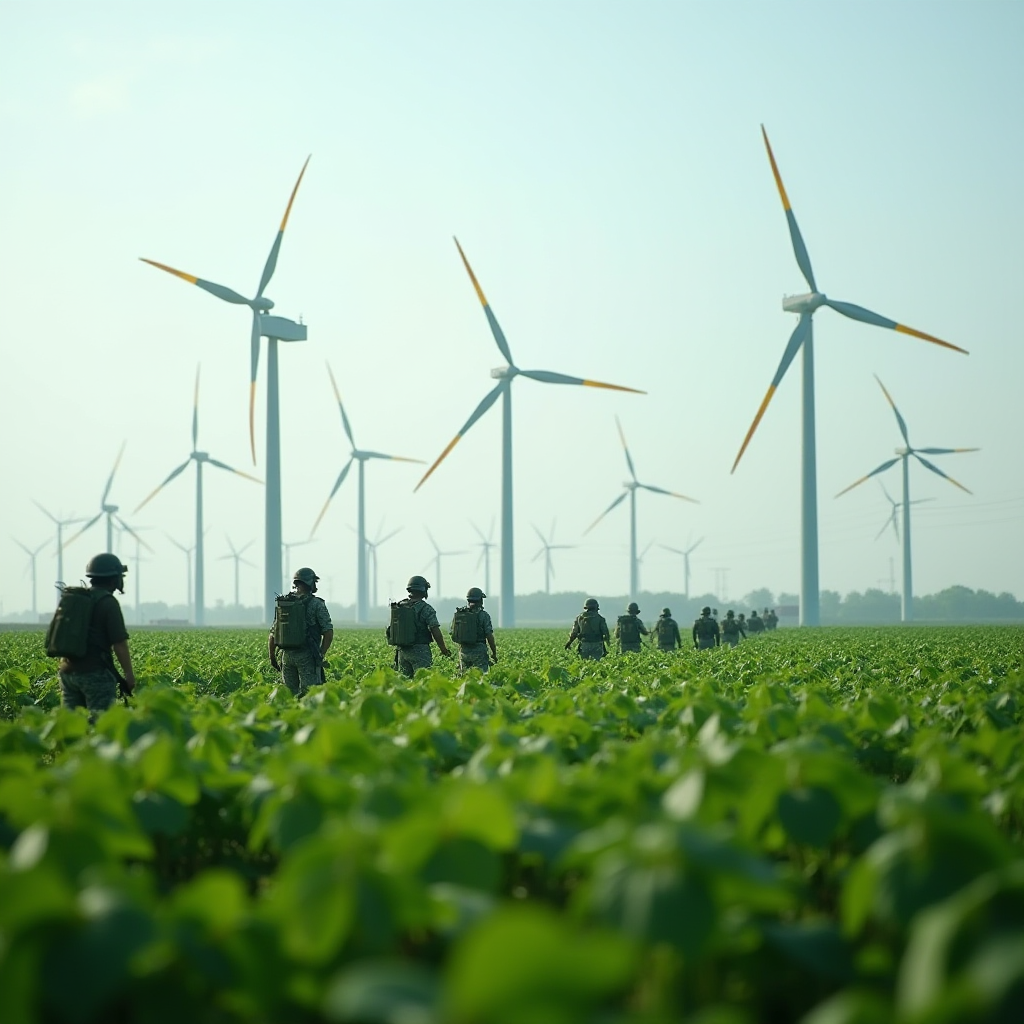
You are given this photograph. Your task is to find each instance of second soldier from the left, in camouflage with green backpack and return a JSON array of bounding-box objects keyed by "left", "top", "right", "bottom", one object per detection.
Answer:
[{"left": 267, "top": 566, "right": 334, "bottom": 697}]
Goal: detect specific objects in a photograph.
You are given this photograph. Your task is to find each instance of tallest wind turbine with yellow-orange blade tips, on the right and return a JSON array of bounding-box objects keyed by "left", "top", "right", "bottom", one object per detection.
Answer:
[{"left": 731, "top": 125, "right": 968, "bottom": 626}]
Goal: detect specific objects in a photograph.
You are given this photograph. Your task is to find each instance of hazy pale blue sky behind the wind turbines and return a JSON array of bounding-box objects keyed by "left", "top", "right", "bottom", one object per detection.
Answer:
[{"left": 0, "top": 2, "right": 1024, "bottom": 610}]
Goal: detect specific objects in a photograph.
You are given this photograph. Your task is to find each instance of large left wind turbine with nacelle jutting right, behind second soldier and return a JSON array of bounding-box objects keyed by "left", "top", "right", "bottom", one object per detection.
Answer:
[{"left": 140, "top": 157, "right": 309, "bottom": 621}]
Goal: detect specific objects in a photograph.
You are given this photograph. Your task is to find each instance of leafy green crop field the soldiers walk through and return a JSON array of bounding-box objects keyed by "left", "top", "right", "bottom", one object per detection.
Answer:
[{"left": 0, "top": 628, "right": 1024, "bottom": 1024}]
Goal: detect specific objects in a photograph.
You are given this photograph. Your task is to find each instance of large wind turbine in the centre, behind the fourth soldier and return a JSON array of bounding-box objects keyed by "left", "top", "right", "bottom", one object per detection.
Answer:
[{"left": 416, "top": 239, "right": 644, "bottom": 627}]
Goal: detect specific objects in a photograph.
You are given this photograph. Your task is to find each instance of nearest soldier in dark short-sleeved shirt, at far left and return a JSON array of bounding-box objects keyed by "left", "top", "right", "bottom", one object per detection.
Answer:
[{"left": 46, "top": 552, "right": 135, "bottom": 721}]
